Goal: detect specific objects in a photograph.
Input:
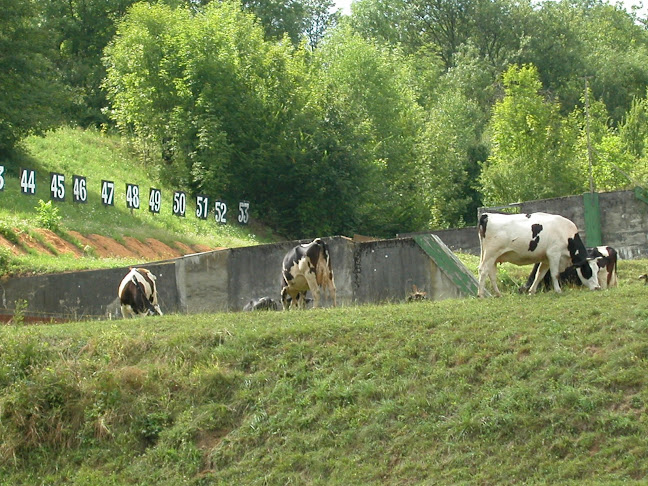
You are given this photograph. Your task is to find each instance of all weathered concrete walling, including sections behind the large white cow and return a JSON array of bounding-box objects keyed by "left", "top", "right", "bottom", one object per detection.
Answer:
[{"left": 13, "top": 186, "right": 648, "bottom": 319}]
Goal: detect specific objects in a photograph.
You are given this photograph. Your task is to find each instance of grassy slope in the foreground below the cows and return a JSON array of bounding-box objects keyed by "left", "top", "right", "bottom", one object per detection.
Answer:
[{"left": 0, "top": 261, "right": 648, "bottom": 486}]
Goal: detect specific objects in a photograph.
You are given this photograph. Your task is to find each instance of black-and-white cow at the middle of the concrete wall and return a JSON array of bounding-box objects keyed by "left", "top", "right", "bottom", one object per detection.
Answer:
[{"left": 281, "top": 238, "right": 336, "bottom": 310}]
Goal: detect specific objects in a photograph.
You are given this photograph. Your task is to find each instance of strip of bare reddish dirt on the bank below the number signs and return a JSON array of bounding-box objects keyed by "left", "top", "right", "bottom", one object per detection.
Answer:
[{"left": 0, "top": 229, "right": 222, "bottom": 261}]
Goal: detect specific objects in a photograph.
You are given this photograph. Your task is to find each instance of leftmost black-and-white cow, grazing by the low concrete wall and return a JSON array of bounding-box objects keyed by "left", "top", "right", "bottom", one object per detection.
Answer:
[{"left": 118, "top": 268, "right": 162, "bottom": 317}]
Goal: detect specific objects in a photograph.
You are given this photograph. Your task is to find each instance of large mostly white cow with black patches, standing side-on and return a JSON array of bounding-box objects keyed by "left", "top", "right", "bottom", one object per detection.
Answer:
[{"left": 478, "top": 213, "right": 600, "bottom": 297}]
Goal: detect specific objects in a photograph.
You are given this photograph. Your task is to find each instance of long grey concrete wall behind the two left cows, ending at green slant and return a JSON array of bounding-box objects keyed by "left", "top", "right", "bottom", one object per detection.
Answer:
[{"left": 0, "top": 237, "right": 468, "bottom": 320}]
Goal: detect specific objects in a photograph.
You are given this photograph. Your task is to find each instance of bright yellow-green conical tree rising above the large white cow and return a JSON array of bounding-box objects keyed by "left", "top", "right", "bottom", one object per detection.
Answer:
[{"left": 481, "top": 66, "right": 583, "bottom": 204}]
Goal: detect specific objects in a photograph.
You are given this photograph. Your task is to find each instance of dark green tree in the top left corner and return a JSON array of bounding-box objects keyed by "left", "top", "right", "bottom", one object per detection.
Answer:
[{"left": 0, "top": 0, "right": 64, "bottom": 157}]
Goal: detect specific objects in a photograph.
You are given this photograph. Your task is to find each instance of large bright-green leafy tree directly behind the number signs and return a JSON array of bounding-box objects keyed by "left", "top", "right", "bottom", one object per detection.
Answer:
[{"left": 106, "top": 3, "right": 277, "bottom": 194}]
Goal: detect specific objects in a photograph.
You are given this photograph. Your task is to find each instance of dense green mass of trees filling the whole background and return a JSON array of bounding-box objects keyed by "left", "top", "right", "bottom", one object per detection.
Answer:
[{"left": 0, "top": 0, "right": 648, "bottom": 237}]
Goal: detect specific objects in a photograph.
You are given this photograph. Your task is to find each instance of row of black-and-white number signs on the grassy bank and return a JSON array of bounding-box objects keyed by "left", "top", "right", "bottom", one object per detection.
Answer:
[{"left": 7, "top": 165, "right": 250, "bottom": 224}]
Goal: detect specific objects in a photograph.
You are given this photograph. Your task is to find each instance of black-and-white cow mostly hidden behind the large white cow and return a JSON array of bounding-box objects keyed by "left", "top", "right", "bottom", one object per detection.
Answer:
[{"left": 520, "top": 246, "right": 618, "bottom": 293}]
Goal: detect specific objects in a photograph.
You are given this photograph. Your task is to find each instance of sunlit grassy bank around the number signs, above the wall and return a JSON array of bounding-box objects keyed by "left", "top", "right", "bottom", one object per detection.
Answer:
[{"left": 0, "top": 128, "right": 272, "bottom": 272}]
